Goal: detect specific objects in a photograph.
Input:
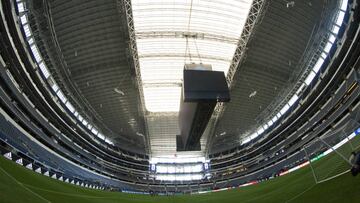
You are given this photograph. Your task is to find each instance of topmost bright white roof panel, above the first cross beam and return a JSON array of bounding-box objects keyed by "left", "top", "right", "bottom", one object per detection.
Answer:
[{"left": 132, "top": 0, "right": 252, "bottom": 38}]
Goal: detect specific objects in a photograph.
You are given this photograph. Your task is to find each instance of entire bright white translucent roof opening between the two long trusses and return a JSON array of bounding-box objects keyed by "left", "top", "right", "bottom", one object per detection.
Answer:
[{"left": 132, "top": 0, "right": 252, "bottom": 112}]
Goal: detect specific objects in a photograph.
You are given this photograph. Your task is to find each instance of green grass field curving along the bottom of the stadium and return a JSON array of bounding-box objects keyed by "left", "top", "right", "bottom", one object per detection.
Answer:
[{"left": 0, "top": 147, "right": 360, "bottom": 203}]
